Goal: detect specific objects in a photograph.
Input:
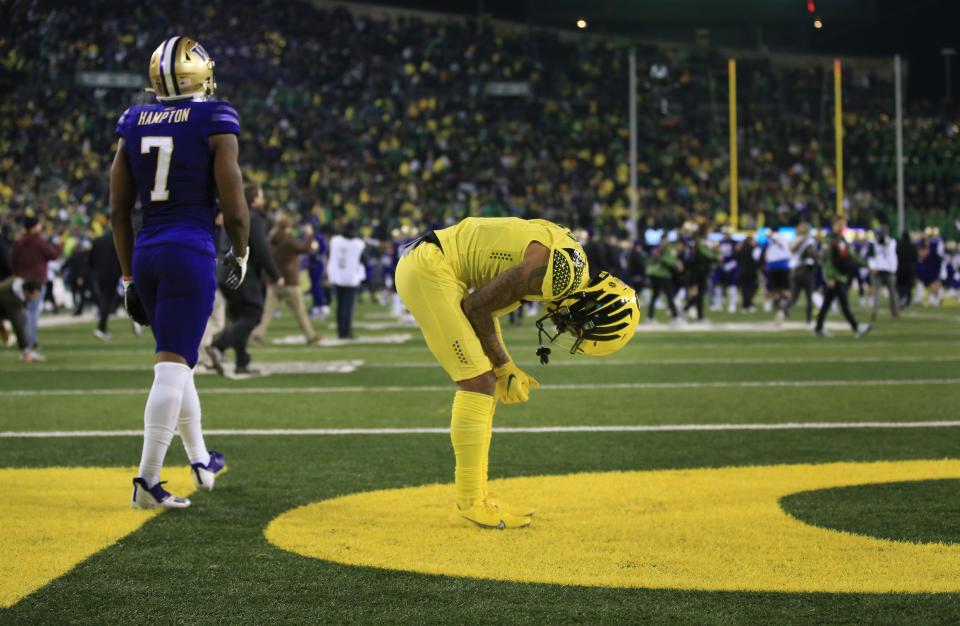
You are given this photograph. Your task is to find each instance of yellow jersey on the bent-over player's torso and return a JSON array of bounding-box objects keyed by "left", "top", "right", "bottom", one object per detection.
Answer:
[{"left": 436, "top": 217, "right": 590, "bottom": 301}]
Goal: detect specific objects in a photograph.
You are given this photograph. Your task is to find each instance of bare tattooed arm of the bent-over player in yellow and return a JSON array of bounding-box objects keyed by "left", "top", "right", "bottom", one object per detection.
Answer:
[{"left": 461, "top": 241, "right": 550, "bottom": 367}]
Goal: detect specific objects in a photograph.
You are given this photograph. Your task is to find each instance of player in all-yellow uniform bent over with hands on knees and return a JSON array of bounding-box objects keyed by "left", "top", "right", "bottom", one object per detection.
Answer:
[{"left": 396, "top": 217, "right": 639, "bottom": 528}]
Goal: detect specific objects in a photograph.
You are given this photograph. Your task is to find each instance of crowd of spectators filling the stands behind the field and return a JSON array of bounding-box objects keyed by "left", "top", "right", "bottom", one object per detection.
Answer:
[{"left": 0, "top": 0, "right": 960, "bottom": 360}]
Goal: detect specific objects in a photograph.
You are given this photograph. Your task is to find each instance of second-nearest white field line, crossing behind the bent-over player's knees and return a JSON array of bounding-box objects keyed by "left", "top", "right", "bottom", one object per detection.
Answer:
[{"left": 0, "top": 378, "right": 960, "bottom": 397}]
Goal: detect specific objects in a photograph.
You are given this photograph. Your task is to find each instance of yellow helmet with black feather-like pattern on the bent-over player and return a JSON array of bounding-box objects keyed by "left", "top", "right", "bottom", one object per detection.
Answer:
[{"left": 537, "top": 272, "right": 640, "bottom": 364}]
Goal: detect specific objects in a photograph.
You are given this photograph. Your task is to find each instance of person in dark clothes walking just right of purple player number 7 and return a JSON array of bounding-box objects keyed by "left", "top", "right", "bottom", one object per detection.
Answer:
[{"left": 207, "top": 183, "right": 284, "bottom": 376}]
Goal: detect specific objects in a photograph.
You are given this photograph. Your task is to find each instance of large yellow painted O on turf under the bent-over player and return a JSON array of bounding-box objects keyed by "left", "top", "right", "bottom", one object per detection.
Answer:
[{"left": 266, "top": 461, "right": 960, "bottom": 593}]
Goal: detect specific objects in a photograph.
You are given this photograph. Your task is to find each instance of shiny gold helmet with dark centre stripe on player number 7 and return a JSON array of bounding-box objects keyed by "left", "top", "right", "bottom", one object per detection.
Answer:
[{"left": 147, "top": 36, "right": 217, "bottom": 102}]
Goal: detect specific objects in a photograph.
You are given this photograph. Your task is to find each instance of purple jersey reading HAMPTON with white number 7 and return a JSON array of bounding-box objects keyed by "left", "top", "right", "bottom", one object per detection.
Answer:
[{"left": 117, "top": 100, "right": 240, "bottom": 255}]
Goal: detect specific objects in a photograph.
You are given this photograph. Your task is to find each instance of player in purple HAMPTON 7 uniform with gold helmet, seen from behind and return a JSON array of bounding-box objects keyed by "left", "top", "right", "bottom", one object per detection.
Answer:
[{"left": 110, "top": 37, "right": 250, "bottom": 509}]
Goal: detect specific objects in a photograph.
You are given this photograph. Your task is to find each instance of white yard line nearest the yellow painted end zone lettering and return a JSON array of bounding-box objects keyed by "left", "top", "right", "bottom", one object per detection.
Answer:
[{"left": 0, "top": 421, "right": 960, "bottom": 439}]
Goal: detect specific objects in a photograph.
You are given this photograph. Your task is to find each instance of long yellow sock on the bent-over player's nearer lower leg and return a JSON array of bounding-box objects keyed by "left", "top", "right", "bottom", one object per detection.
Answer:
[{"left": 450, "top": 391, "right": 496, "bottom": 508}]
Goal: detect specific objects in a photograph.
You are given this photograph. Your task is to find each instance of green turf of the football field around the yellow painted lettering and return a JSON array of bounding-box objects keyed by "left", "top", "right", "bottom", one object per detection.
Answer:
[{"left": 0, "top": 304, "right": 960, "bottom": 624}]
